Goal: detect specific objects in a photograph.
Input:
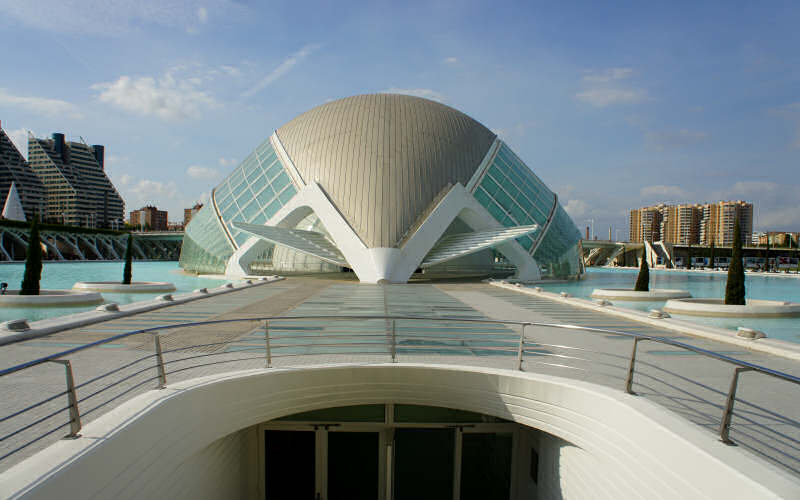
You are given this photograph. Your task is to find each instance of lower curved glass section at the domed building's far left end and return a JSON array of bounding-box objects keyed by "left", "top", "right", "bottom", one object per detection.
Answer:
[{"left": 179, "top": 203, "right": 234, "bottom": 274}]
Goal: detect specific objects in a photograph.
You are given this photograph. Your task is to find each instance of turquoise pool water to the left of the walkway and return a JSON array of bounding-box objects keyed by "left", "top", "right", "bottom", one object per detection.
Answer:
[{"left": 0, "top": 261, "right": 227, "bottom": 321}]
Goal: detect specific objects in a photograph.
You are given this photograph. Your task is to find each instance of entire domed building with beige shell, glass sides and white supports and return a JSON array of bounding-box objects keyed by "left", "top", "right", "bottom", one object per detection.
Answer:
[{"left": 180, "top": 94, "right": 582, "bottom": 283}]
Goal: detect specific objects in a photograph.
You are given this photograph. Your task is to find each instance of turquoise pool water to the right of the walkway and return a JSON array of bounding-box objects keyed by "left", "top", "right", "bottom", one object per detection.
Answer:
[{"left": 538, "top": 268, "right": 800, "bottom": 343}]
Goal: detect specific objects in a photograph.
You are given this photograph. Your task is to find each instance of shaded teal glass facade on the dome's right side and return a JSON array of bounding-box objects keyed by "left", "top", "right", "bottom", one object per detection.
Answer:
[{"left": 473, "top": 143, "right": 581, "bottom": 277}]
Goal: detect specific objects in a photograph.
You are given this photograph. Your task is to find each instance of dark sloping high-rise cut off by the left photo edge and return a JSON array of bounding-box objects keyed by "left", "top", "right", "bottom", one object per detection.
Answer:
[{"left": 0, "top": 121, "right": 45, "bottom": 220}]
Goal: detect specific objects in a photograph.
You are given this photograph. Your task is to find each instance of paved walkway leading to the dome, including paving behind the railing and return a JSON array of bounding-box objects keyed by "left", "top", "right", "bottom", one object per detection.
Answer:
[{"left": 0, "top": 278, "right": 800, "bottom": 475}]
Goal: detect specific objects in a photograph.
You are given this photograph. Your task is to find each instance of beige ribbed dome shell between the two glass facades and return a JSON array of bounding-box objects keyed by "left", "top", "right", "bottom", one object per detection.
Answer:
[{"left": 277, "top": 94, "right": 495, "bottom": 248}]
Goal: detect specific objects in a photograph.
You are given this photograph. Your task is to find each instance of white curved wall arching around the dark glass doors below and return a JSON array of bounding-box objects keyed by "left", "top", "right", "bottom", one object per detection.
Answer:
[{"left": 0, "top": 364, "right": 800, "bottom": 499}]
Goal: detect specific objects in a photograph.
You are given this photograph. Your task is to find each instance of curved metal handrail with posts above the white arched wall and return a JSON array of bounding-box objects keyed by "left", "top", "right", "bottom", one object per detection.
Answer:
[{"left": 0, "top": 315, "right": 800, "bottom": 459}]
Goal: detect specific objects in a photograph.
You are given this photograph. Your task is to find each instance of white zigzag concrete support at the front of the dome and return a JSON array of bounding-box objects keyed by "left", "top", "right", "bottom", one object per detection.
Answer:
[{"left": 226, "top": 182, "right": 541, "bottom": 283}]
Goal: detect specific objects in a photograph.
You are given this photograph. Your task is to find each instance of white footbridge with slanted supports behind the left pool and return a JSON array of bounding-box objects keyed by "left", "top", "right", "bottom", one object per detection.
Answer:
[{"left": 0, "top": 221, "right": 183, "bottom": 262}]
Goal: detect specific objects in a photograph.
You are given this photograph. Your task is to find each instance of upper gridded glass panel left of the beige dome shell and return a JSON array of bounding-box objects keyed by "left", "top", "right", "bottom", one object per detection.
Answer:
[{"left": 214, "top": 139, "right": 297, "bottom": 246}]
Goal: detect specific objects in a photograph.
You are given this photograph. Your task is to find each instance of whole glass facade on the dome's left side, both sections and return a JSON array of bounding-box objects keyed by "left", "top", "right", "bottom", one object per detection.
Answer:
[{"left": 180, "top": 139, "right": 297, "bottom": 273}]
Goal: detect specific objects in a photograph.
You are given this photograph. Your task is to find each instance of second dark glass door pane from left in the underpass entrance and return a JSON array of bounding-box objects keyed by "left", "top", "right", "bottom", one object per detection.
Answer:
[{"left": 328, "top": 432, "right": 380, "bottom": 500}]
